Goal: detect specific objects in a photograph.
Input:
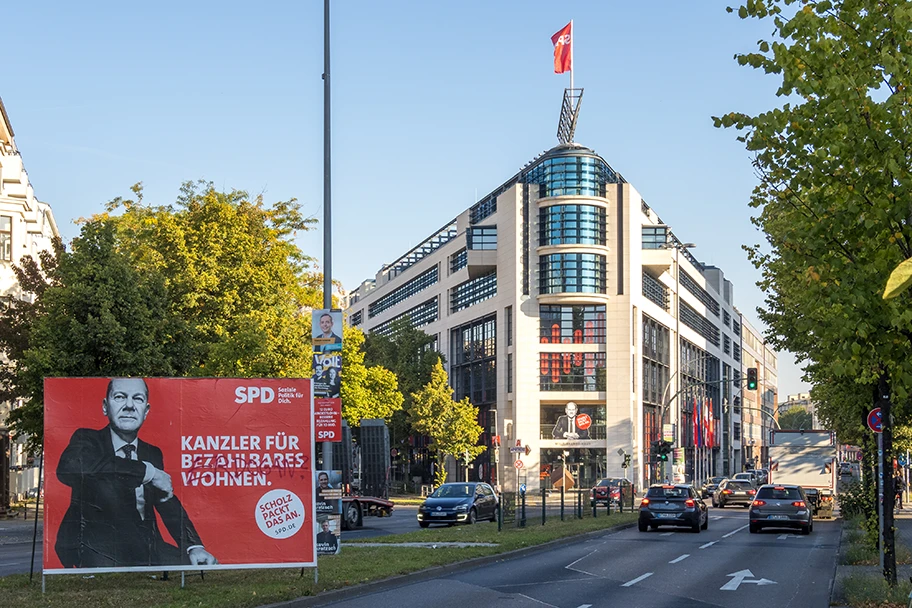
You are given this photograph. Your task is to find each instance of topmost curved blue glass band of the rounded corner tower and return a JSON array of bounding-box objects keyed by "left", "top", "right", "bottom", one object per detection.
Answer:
[{"left": 526, "top": 155, "right": 618, "bottom": 198}]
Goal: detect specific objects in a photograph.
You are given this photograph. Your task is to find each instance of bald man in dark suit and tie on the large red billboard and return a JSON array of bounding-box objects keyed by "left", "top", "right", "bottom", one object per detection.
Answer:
[{"left": 55, "top": 378, "right": 218, "bottom": 568}]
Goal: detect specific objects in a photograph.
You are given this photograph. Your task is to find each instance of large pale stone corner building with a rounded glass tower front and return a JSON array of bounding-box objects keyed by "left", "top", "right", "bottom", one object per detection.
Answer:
[{"left": 346, "top": 143, "right": 772, "bottom": 491}]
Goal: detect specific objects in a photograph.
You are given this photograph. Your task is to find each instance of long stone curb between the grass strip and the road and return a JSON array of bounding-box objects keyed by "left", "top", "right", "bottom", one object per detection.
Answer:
[{"left": 260, "top": 522, "right": 636, "bottom": 608}]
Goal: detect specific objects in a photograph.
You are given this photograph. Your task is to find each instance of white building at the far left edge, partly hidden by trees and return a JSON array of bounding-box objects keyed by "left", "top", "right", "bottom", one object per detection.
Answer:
[{"left": 0, "top": 100, "right": 60, "bottom": 510}]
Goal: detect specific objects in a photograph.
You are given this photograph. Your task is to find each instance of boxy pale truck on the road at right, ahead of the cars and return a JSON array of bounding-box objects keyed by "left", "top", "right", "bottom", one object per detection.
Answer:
[{"left": 769, "top": 429, "right": 837, "bottom": 518}]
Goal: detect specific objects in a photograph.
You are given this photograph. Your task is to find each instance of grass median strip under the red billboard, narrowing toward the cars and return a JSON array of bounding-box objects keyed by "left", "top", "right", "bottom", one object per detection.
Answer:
[{"left": 0, "top": 513, "right": 637, "bottom": 608}]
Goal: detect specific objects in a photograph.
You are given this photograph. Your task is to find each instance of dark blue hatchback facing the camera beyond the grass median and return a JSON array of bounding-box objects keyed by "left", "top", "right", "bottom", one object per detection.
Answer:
[{"left": 418, "top": 482, "right": 497, "bottom": 528}]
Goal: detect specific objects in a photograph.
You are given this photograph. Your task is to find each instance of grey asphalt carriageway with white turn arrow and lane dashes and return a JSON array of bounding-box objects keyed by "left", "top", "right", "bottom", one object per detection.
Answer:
[{"left": 316, "top": 508, "right": 839, "bottom": 608}]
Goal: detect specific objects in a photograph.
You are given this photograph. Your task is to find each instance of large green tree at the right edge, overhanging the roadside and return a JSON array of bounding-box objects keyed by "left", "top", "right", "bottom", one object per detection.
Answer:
[{"left": 715, "top": 0, "right": 912, "bottom": 584}]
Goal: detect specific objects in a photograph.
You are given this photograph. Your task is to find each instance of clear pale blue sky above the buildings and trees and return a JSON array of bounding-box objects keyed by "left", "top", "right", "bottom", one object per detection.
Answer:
[{"left": 0, "top": 0, "right": 807, "bottom": 398}]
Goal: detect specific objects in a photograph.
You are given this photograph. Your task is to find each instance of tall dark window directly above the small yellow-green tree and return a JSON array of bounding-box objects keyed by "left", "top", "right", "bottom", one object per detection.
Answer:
[{"left": 450, "top": 315, "right": 497, "bottom": 405}]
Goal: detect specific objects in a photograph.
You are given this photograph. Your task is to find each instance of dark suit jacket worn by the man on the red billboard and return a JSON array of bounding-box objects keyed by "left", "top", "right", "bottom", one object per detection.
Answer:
[{"left": 55, "top": 427, "right": 203, "bottom": 568}]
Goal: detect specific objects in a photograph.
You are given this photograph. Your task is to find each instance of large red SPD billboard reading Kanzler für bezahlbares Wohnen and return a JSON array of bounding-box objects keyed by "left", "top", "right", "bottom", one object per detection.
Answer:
[{"left": 44, "top": 378, "right": 317, "bottom": 574}]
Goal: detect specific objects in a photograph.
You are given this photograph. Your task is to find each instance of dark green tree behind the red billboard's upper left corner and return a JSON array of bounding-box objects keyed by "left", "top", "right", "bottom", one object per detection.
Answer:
[{"left": 0, "top": 221, "right": 191, "bottom": 452}]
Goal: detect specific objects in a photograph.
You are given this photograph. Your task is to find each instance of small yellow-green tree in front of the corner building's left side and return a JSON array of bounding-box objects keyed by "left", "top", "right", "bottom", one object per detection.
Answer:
[{"left": 409, "top": 359, "right": 484, "bottom": 486}]
